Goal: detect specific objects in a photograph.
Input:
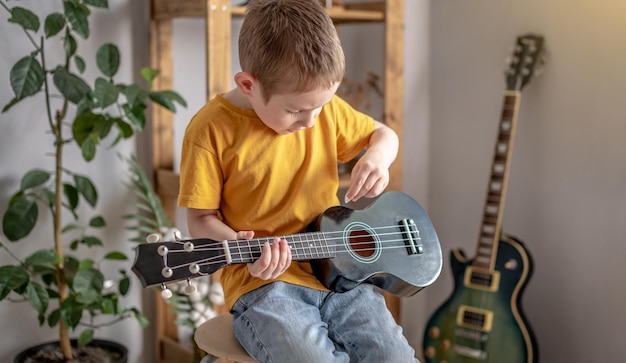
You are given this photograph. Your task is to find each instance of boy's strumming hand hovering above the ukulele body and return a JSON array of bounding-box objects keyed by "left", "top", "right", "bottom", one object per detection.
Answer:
[{"left": 345, "top": 150, "right": 389, "bottom": 203}]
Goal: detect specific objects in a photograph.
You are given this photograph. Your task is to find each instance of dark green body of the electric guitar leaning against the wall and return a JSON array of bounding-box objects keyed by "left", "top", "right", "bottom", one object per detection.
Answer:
[{"left": 423, "top": 237, "right": 538, "bottom": 363}]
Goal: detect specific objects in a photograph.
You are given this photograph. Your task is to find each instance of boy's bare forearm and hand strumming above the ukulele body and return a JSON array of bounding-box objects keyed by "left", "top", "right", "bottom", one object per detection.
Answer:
[{"left": 345, "top": 121, "right": 400, "bottom": 203}]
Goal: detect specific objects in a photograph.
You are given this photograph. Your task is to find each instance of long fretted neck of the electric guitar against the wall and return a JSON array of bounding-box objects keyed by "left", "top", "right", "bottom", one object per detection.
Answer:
[{"left": 473, "top": 91, "right": 521, "bottom": 270}]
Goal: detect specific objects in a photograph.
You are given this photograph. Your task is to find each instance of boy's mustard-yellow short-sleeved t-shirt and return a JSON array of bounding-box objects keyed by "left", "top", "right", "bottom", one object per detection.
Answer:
[{"left": 178, "top": 95, "right": 375, "bottom": 309}]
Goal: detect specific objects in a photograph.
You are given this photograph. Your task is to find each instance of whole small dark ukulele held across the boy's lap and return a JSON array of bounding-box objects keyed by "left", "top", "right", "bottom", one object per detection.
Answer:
[{"left": 132, "top": 192, "right": 442, "bottom": 296}]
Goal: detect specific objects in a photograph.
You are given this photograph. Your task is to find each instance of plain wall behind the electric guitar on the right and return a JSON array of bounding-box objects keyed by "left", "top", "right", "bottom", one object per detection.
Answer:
[{"left": 422, "top": 0, "right": 626, "bottom": 362}]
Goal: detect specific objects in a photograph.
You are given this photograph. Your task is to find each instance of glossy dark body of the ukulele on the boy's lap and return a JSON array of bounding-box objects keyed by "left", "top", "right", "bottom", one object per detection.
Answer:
[{"left": 311, "top": 192, "right": 443, "bottom": 296}]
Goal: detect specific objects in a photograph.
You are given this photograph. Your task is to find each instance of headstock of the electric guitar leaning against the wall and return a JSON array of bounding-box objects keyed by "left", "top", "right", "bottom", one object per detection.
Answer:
[{"left": 506, "top": 34, "right": 544, "bottom": 91}]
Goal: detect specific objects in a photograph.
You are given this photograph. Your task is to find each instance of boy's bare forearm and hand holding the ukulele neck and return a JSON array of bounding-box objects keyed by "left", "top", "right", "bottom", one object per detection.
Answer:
[{"left": 187, "top": 208, "right": 291, "bottom": 280}]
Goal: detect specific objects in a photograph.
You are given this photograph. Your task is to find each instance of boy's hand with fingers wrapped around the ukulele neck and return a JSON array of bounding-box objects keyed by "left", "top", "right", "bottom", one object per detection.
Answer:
[{"left": 243, "top": 231, "right": 291, "bottom": 280}]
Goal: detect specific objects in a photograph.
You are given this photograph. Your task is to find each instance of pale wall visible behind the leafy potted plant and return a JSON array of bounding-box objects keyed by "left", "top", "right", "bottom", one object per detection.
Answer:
[{"left": 0, "top": 0, "right": 154, "bottom": 363}]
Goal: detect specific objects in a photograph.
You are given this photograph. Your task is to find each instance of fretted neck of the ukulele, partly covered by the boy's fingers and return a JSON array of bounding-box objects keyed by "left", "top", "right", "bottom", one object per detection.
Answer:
[{"left": 224, "top": 232, "right": 336, "bottom": 263}]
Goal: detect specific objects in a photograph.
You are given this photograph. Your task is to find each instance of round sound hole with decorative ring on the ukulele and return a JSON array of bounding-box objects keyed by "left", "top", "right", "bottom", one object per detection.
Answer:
[{"left": 343, "top": 222, "right": 382, "bottom": 263}]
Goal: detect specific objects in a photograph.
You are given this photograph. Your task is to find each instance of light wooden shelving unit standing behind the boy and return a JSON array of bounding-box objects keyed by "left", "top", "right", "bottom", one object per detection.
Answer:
[{"left": 150, "top": 0, "right": 404, "bottom": 363}]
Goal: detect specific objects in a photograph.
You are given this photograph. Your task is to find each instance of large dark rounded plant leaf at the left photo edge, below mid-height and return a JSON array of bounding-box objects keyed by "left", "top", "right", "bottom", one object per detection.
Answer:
[{"left": 2, "top": 199, "right": 39, "bottom": 242}]
